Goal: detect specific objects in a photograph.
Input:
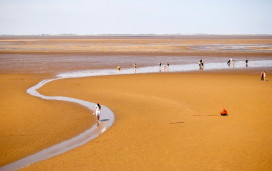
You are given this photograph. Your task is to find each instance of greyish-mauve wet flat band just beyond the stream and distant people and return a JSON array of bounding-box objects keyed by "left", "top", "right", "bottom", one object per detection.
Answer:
[{"left": 0, "top": 54, "right": 272, "bottom": 74}]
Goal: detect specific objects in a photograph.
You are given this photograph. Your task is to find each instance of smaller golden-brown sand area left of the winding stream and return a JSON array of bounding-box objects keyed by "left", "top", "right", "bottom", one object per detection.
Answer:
[{"left": 0, "top": 74, "right": 94, "bottom": 166}]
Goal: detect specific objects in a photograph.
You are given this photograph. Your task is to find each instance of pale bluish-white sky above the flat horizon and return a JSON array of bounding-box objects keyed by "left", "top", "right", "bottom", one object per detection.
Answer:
[{"left": 0, "top": 0, "right": 272, "bottom": 35}]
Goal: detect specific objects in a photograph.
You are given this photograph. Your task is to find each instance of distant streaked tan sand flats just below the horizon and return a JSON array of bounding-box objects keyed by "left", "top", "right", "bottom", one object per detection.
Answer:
[{"left": 0, "top": 35, "right": 272, "bottom": 56}]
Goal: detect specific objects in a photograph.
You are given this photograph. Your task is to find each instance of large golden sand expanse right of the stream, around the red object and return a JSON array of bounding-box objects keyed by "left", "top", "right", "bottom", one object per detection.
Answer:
[{"left": 16, "top": 72, "right": 272, "bottom": 170}]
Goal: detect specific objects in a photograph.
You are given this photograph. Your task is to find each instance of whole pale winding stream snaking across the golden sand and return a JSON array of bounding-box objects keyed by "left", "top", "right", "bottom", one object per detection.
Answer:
[{"left": 0, "top": 60, "right": 272, "bottom": 171}]
